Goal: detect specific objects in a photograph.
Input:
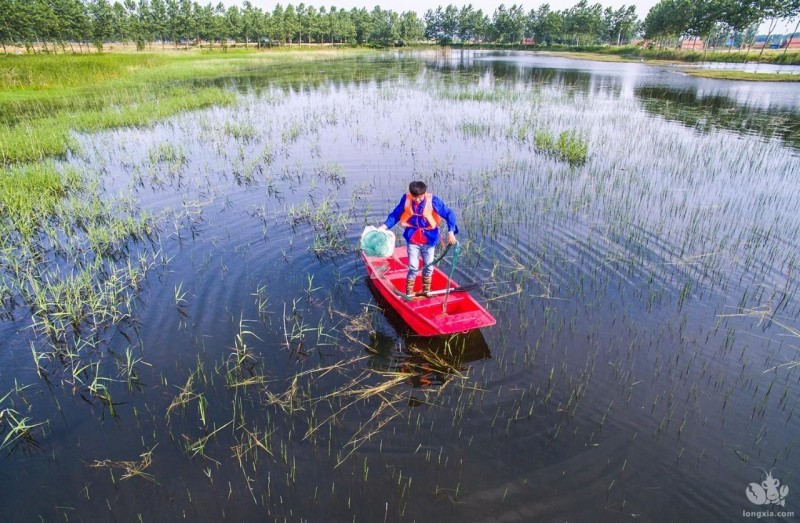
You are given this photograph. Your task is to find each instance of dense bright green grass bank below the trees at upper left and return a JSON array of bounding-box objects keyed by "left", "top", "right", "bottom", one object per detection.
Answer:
[{"left": 0, "top": 51, "right": 394, "bottom": 164}]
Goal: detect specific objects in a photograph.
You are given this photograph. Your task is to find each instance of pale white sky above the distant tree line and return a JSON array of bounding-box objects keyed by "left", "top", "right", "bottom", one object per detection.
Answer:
[{"left": 214, "top": 0, "right": 796, "bottom": 34}]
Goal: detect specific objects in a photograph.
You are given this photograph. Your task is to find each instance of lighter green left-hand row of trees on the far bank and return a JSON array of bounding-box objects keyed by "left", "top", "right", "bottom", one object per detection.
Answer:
[{"left": 0, "top": 0, "right": 432, "bottom": 51}]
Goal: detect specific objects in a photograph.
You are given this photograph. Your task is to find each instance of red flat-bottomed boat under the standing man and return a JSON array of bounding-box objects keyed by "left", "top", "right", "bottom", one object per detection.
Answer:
[{"left": 361, "top": 246, "right": 495, "bottom": 336}]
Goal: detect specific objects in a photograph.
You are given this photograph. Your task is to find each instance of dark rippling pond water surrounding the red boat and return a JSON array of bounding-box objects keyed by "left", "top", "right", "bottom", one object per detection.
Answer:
[{"left": 0, "top": 53, "right": 800, "bottom": 521}]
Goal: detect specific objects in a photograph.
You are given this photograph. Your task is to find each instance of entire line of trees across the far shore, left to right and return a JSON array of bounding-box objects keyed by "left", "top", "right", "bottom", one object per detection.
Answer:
[{"left": 0, "top": 0, "right": 800, "bottom": 52}]
